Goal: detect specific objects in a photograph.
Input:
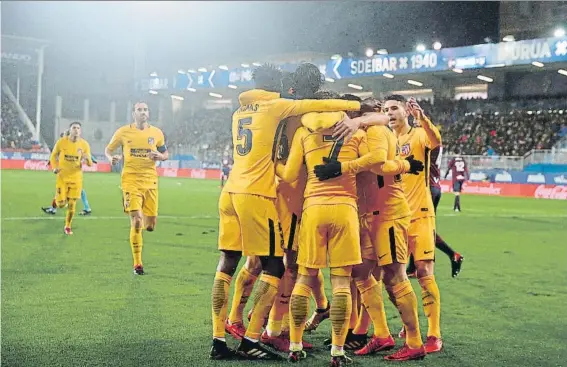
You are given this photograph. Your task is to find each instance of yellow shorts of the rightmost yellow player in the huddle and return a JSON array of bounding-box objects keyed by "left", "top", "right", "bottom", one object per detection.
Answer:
[{"left": 408, "top": 217, "right": 436, "bottom": 261}]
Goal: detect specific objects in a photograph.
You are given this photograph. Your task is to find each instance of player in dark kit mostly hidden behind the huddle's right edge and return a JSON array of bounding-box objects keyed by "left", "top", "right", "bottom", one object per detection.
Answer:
[{"left": 407, "top": 146, "right": 465, "bottom": 278}]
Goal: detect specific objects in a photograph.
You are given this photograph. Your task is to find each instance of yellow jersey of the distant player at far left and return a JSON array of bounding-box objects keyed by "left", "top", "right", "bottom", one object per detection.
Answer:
[{"left": 49, "top": 136, "right": 93, "bottom": 182}]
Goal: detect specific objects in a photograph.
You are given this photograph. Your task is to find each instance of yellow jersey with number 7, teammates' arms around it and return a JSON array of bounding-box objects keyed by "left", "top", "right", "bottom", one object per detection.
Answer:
[{"left": 277, "top": 112, "right": 367, "bottom": 210}]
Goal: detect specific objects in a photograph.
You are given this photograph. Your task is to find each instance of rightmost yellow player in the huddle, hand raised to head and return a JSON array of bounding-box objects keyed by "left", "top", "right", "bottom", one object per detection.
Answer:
[{"left": 384, "top": 95, "right": 443, "bottom": 353}]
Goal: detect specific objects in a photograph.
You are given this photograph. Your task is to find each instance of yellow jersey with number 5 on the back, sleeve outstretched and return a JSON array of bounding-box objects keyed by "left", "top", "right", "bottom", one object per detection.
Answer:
[{"left": 223, "top": 89, "right": 360, "bottom": 198}]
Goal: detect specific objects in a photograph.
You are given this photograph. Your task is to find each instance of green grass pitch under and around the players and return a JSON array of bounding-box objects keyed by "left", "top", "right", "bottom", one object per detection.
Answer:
[{"left": 1, "top": 171, "right": 567, "bottom": 367}]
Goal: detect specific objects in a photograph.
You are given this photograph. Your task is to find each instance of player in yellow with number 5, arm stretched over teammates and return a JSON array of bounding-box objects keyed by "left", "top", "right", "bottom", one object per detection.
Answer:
[{"left": 210, "top": 65, "right": 366, "bottom": 359}]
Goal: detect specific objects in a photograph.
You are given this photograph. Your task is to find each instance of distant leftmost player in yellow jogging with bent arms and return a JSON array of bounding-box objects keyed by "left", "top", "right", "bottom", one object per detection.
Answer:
[{"left": 49, "top": 122, "right": 93, "bottom": 235}]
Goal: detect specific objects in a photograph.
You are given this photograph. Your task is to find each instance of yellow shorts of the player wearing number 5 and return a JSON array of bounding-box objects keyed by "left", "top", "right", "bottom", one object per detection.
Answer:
[{"left": 219, "top": 191, "right": 283, "bottom": 257}]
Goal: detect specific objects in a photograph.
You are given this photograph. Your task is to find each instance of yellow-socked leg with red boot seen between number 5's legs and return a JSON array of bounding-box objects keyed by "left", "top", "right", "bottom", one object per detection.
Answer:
[{"left": 225, "top": 256, "right": 262, "bottom": 340}]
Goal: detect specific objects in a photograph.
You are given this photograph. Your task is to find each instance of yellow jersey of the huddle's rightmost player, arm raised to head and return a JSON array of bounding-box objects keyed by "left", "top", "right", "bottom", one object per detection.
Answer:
[{"left": 398, "top": 121, "right": 441, "bottom": 219}]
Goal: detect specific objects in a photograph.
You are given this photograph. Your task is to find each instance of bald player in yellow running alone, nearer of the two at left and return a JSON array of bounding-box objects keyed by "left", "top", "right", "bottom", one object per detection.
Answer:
[{"left": 104, "top": 102, "right": 169, "bottom": 275}]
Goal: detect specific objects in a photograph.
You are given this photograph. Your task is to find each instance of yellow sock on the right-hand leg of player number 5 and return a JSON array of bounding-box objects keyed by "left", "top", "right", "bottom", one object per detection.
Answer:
[{"left": 245, "top": 274, "right": 280, "bottom": 340}]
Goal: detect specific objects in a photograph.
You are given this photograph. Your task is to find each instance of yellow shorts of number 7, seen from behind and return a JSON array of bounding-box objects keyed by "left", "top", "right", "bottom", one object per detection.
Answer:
[{"left": 297, "top": 204, "right": 362, "bottom": 269}]
